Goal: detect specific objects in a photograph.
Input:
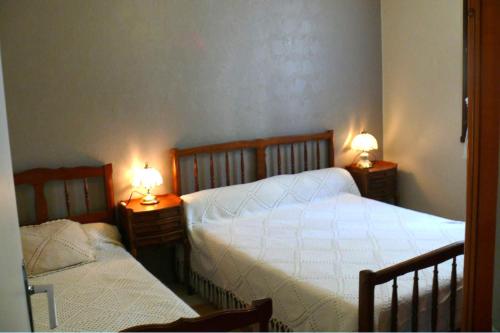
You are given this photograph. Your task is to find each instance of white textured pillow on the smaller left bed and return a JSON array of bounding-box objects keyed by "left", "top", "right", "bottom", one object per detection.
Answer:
[{"left": 21, "top": 220, "right": 95, "bottom": 277}]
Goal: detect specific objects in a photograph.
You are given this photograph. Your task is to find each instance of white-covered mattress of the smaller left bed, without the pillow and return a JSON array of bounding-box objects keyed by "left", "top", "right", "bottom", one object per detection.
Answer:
[{"left": 29, "top": 224, "right": 197, "bottom": 331}]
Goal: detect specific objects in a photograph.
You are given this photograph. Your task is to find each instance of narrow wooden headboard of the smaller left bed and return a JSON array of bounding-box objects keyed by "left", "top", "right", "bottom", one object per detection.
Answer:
[{"left": 14, "top": 164, "right": 115, "bottom": 224}]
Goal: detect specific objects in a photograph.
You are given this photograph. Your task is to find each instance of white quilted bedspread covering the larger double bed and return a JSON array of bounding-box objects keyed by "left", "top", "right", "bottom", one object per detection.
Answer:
[{"left": 183, "top": 168, "right": 464, "bottom": 331}]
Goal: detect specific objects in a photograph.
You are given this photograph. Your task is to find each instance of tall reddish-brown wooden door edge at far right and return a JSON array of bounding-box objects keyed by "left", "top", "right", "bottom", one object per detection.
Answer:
[{"left": 462, "top": 0, "right": 500, "bottom": 331}]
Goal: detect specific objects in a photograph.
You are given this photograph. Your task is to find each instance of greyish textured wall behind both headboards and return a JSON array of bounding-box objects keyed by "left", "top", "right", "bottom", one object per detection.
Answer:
[{"left": 0, "top": 0, "right": 382, "bottom": 205}]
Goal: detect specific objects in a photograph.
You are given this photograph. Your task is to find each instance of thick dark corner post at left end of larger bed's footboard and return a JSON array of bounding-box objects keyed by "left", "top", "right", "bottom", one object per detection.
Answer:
[{"left": 358, "top": 270, "right": 375, "bottom": 332}]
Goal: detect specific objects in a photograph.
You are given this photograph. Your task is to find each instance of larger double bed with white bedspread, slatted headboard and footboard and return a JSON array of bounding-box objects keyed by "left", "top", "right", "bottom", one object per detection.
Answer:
[{"left": 171, "top": 131, "right": 465, "bottom": 331}]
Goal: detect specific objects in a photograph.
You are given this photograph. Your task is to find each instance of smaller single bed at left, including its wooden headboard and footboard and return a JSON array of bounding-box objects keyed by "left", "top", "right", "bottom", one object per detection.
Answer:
[{"left": 15, "top": 164, "right": 272, "bottom": 331}]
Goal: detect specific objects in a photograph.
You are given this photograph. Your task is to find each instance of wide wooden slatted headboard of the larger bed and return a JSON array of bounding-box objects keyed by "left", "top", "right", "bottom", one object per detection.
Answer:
[{"left": 170, "top": 130, "right": 335, "bottom": 195}]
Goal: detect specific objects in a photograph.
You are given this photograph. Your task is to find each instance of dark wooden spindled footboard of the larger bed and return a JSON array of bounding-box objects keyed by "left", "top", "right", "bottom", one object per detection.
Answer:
[{"left": 358, "top": 242, "right": 464, "bottom": 332}]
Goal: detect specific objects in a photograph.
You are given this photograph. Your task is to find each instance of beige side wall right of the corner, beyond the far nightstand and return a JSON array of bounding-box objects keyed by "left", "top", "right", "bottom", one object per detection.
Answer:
[{"left": 381, "top": 0, "right": 466, "bottom": 219}]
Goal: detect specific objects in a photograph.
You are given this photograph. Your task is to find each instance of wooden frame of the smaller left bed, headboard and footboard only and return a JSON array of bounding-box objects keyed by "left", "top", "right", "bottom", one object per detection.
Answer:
[{"left": 14, "top": 164, "right": 272, "bottom": 332}]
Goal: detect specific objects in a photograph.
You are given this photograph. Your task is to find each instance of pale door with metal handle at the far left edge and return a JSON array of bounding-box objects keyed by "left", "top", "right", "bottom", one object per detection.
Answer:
[{"left": 0, "top": 46, "right": 31, "bottom": 331}]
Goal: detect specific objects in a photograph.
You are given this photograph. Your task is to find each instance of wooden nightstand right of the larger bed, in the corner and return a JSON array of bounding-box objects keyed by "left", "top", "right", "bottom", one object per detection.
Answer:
[{"left": 346, "top": 161, "right": 399, "bottom": 205}]
